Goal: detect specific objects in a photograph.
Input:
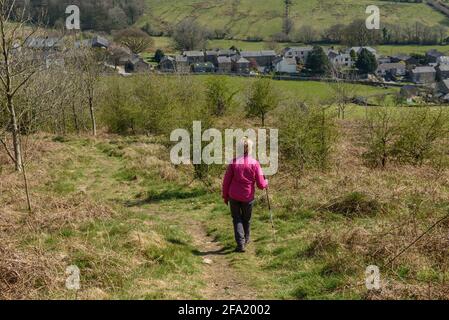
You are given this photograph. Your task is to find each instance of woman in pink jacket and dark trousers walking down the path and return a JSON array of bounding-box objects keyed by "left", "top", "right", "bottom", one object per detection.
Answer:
[{"left": 222, "top": 138, "right": 268, "bottom": 252}]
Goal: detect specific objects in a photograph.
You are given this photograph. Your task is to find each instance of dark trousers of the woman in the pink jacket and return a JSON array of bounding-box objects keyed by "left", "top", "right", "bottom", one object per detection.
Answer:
[{"left": 229, "top": 199, "right": 254, "bottom": 248}]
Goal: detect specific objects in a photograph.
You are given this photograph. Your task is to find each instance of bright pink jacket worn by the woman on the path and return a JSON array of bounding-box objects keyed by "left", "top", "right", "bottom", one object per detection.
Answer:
[{"left": 222, "top": 156, "right": 268, "bottom": 202}]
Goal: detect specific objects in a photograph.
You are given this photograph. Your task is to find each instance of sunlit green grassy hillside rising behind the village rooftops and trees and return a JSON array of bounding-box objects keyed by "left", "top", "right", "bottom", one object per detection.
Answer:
[{"left": 139, "top": 0, "right": 449, "bottom": 39}]
